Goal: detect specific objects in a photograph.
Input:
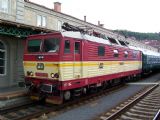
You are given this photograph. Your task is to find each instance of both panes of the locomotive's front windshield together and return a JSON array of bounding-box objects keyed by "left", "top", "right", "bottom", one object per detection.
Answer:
[{"left": 27, "top": 38, "right": 60, "bottom": 53}]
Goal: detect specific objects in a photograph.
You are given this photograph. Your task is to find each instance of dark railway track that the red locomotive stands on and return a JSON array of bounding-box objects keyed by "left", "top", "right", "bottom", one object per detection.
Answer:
[{"left": 0, "top": 84, "right": 126, "bottom": 120}]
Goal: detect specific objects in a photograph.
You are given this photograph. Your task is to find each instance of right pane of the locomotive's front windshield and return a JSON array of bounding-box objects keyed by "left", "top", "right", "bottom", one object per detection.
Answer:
[{"left": 43, "top": 38, "right": 59, "bottom": 52}]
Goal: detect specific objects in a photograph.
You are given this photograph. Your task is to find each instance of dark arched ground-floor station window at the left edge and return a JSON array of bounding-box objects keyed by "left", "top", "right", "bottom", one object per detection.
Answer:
[{"left": 0, "top": 41, "right": 6, "bottom": 75}]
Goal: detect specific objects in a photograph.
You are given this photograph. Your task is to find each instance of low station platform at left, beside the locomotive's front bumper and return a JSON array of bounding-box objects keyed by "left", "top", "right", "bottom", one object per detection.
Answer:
[{"left": 0, "top": 86, "right": 30, "bottom": 110}]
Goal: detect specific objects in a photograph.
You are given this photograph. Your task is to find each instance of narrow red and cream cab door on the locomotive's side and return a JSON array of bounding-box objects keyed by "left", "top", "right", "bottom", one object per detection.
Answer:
[{"left": 73, "top": 40, "right": 82, "bottom": 78}]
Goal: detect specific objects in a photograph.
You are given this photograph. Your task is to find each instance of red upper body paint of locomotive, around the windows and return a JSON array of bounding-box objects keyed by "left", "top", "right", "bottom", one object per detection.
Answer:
[{"left": 24, "top": 33, "right": 141, "bottom": 62}]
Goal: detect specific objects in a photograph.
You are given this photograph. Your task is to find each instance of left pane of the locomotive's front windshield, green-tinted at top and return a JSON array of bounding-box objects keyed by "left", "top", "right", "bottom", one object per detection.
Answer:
[{"left": 27, "top": 40, "right": 41, "bottom": 52}]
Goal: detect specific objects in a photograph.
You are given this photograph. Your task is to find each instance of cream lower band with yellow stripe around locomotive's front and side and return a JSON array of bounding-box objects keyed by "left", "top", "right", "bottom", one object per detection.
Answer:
[{"left": 24, "top": 61, "right": 142, "bottom": 81}]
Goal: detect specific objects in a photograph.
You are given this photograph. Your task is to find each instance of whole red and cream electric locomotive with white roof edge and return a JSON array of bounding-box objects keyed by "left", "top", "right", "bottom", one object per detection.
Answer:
[{"left": 23, "top": 24, "right": 142, "bottom": 104}]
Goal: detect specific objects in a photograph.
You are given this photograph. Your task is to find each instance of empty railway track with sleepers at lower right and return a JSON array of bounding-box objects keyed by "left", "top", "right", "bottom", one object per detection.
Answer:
[{"left": 96, "top": 84, "right": 160, "bottom": 120}]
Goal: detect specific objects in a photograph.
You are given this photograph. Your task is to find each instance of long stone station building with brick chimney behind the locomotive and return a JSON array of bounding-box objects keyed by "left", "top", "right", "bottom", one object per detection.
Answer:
[{"left": 0, "top": 0, "right": 157, "bottom": 88}]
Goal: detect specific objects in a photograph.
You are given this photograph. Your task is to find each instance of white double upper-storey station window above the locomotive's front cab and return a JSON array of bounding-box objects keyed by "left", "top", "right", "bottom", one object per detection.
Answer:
[{"left": 37, "top": 15, "right": 47, "bottom": 27}]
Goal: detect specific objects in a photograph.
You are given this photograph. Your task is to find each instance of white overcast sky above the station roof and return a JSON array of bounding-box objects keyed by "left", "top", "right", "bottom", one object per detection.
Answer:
[{"left": 30, "top": 0, "right": 160, "bottom": 32}]
